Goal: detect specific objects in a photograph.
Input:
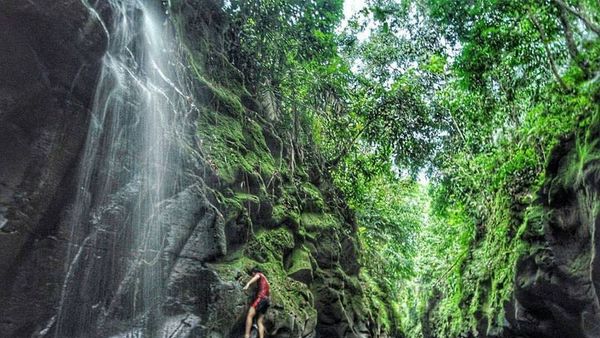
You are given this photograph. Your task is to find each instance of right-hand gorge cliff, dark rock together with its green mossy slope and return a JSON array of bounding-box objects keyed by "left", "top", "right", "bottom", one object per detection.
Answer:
[{"left": 421, "top": 111, "right": 600, "bottom": 338}]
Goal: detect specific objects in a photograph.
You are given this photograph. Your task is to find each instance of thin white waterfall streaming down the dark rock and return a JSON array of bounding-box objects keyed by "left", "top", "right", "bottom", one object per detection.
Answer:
[{"left": 51, "top": 0, "right": 194, "bottom": 338}]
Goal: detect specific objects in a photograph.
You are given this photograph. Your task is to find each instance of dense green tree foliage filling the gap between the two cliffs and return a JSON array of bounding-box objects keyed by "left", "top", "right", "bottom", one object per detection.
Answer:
[{"left": 226, "top": 0, "right": 600, "bottom": 337}]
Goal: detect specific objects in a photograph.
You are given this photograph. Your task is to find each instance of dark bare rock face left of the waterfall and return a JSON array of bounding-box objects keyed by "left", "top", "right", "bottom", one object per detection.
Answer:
[{"left": 0, "top": 0, "right": 106, "bottom": 336}]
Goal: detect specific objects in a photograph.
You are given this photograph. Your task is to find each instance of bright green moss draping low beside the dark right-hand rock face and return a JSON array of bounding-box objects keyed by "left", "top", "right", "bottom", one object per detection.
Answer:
[{"left": 424, "top": 191, "right": 528, "bottom": 337}]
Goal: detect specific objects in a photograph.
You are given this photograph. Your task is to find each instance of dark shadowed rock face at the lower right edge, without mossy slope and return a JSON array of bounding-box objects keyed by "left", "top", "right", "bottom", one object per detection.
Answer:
[{"left": 508, "top": 133, "right": 600, "bottom": 338}]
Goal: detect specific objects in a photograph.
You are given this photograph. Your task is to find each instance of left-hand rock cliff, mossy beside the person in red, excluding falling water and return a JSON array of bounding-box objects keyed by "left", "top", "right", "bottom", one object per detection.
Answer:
[{"left": 0, "top": 0, "right": 386, "bottom": 338}]
